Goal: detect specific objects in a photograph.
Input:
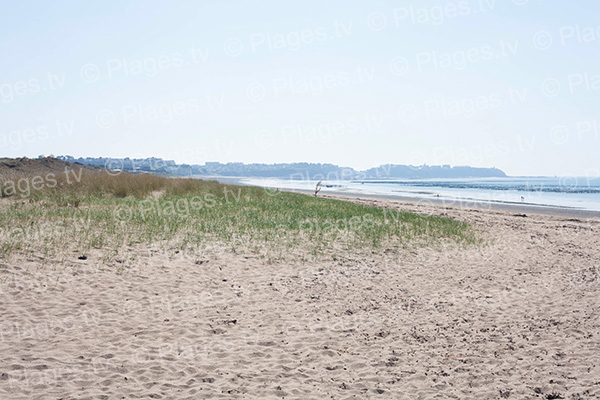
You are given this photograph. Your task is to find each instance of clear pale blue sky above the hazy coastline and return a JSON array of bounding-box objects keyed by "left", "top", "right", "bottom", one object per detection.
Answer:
[{"left": 0, "top": 0, "right": 600, "bottom": 177}]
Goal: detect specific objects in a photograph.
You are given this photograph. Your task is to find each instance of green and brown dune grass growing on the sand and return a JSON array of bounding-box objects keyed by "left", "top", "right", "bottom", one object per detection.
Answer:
[{"left": 0, "top": 172, "right": 478, "bottom": 258}]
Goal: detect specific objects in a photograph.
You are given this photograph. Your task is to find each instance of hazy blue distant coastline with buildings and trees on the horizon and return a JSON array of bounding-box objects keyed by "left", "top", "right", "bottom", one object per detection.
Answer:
[{"left": 54, "top": 155, "right": 506, "bottom": 180}]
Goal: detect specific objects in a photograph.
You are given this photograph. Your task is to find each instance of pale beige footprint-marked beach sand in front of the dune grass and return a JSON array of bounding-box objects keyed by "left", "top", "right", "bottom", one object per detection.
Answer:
[{"left": 0, "top": 199, "right": 600, "bottom": 399}]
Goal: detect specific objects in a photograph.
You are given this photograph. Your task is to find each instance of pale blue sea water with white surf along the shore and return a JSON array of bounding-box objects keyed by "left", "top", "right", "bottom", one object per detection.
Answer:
[{"left": 241, "top": 177, "right": 600, "bottom": 211}]
